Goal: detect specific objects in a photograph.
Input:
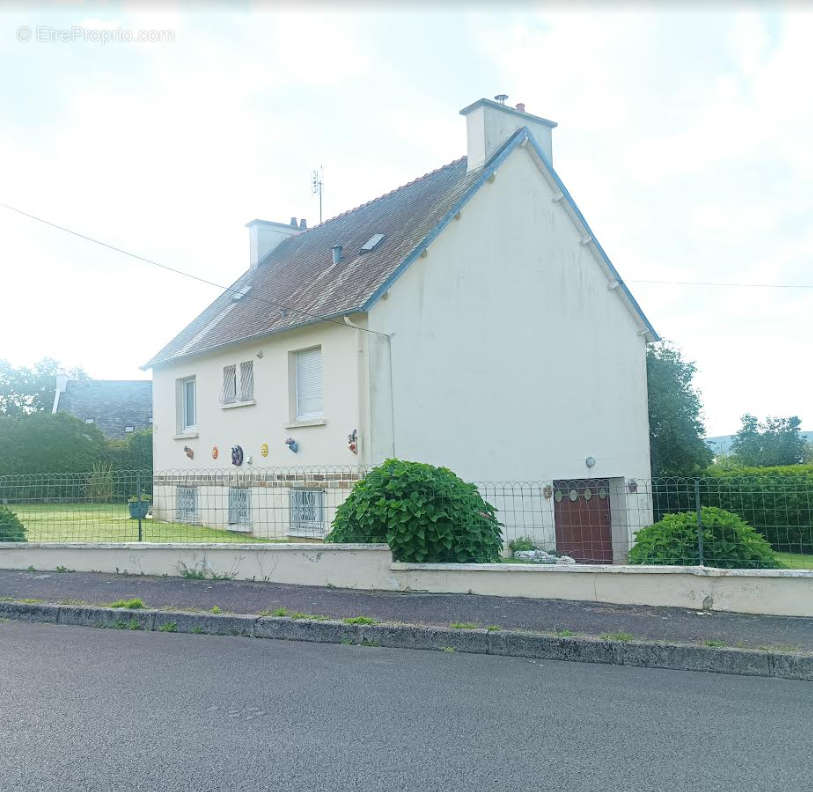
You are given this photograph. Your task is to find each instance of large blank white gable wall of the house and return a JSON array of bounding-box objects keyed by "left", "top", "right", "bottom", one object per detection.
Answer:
[{"left": 369, "top": 148, "right": 649, "bottom": 481}]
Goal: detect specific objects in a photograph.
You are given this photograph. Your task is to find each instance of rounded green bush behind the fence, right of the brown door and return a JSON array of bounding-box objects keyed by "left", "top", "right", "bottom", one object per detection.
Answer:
[{"left": 629, "top": 506, "right": 781, "bottom": 569}]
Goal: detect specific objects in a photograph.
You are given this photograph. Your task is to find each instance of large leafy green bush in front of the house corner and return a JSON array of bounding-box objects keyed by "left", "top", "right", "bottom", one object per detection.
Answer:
[{"left": 325, "top": 459, "right": 502, "bottom": 563}]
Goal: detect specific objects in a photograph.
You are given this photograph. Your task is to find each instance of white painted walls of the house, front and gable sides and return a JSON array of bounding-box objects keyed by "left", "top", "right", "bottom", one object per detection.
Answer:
[{"left": 154, "top": 99, "right": 651, "bottom": 561}]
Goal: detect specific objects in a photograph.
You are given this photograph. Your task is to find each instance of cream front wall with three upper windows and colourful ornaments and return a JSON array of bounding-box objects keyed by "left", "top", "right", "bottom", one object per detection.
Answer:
[{"left": 153, "top": 323, "right": 360, "bottom": 473}]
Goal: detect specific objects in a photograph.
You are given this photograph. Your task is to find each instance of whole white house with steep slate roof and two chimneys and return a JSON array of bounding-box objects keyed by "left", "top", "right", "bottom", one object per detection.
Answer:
[{"left": 147, "top": 99, "right": 657, "bottom": 561}]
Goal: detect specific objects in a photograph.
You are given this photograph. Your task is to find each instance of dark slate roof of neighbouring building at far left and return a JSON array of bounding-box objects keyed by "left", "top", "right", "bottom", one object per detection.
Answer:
[{"left": 53, "top": 379, "right": 152, "bottom": 438}]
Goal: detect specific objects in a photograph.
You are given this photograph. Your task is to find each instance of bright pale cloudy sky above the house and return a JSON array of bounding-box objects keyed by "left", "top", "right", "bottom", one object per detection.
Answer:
[{"left": 0, "top": 3, "right": 813, "bottom": 435}]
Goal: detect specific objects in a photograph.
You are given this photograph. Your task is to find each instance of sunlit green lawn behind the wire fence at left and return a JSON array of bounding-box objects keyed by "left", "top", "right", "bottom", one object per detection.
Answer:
[{"left": 9, "top": 503, "right": 280, "bottom": 543}]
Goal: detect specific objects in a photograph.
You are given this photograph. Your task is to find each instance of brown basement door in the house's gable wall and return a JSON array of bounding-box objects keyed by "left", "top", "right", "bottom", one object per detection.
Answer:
[{"left": 553, "top": 479, "right": 613, "bottom": 564}]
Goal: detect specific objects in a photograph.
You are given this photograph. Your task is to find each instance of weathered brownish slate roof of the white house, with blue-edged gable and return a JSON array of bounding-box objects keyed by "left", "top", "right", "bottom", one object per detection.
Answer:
[{"left": 144, "top": 127, "right": 658, "bottom": 368}]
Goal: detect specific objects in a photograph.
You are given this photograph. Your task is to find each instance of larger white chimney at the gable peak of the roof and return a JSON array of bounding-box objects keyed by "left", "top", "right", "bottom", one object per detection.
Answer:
[{"left": 460, "top": 94, "right": 556, "bottom": 172}]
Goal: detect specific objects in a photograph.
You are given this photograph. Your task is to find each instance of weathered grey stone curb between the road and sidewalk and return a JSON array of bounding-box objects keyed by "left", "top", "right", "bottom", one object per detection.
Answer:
[{"left": 0, "top": 602, "right": 813, "bottom": 681}]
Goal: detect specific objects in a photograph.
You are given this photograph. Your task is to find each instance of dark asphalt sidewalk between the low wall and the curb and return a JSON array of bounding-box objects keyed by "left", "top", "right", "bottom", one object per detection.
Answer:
[{"left": 0, "top": 570, "right": 813, "bottom": 652}]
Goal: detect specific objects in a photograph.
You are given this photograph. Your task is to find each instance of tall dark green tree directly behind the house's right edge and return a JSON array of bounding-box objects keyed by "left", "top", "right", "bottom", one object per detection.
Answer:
[{"left": 646, "top": 342, "right": 713, "bottom": 476}]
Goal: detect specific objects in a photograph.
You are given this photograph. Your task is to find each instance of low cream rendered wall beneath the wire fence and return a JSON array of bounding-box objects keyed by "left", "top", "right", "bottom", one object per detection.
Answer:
[{"left": 0, "top": 542, "right": 813, "bottom": 617}]
